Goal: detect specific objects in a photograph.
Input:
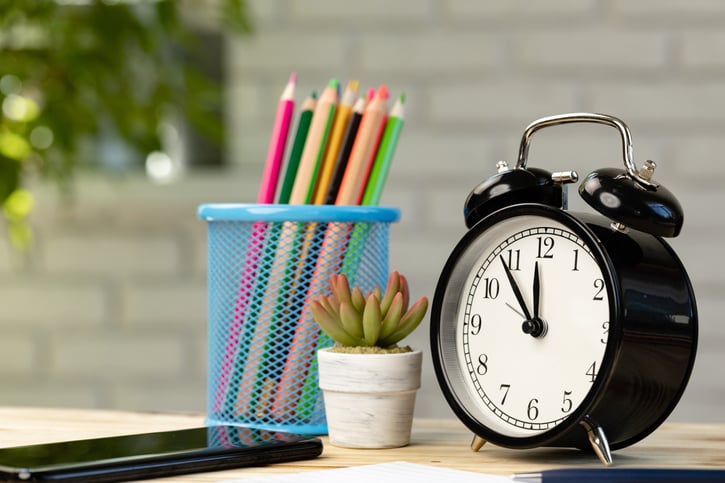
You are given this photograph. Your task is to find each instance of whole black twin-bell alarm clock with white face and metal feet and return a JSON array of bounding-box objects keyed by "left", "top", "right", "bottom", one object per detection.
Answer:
[{"left": 430, "top": 113, "right": 697, "bottom": 465}]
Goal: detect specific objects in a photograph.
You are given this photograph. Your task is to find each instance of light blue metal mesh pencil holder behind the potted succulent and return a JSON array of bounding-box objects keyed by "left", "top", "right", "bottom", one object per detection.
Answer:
[{"left": 198, "top": 204, "right": 400, "bottom": 434}]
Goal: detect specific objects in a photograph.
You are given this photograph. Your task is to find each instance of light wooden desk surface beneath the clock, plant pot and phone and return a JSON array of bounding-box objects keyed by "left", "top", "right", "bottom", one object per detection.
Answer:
[{"left": 0, "top": 407, "right": 725, "bottom": 482}]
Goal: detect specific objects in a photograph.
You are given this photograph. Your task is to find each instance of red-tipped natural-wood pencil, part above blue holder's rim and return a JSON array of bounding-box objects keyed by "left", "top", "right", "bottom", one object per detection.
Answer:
[{"left": 335, "top": 85, "right": 388, "bottom": 205}]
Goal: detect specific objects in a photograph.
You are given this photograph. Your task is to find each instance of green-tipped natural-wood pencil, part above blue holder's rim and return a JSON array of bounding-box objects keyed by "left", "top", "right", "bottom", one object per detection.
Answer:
[{"left": 290, "top": 79, "right": 339, "bottom": 204}]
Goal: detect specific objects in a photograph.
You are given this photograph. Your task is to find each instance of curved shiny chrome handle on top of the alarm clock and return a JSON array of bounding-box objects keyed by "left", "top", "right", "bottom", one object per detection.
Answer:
[{"left": 516, "top": 112, "right": 657, "bottom": 188}]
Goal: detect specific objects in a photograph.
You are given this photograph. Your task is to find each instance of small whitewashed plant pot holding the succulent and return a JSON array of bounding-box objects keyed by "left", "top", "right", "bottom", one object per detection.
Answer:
[{"left": 317, "top": 349, "right": 423, "bottom": 448}]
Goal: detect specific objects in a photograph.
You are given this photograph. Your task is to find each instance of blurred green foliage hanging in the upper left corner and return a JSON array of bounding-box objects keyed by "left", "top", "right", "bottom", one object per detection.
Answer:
[{"left": 0, "top": 0, "right": 251, "bottom": 247}]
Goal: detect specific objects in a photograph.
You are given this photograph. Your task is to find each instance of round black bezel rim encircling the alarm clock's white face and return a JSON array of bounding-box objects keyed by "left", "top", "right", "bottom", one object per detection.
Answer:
[{"left": 430, "top": 203, "right": 623, "bottom": 449}]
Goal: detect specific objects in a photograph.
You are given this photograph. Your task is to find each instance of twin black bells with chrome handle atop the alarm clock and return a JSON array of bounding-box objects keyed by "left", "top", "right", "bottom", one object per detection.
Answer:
[{"left": 464, "top": 113, "right": 684, "bottom": 237}]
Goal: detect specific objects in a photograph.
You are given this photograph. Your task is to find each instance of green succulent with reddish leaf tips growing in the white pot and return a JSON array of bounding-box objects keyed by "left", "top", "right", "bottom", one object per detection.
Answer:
[{"left": 310, "top": 272, "right": 428, "bottom": 348}]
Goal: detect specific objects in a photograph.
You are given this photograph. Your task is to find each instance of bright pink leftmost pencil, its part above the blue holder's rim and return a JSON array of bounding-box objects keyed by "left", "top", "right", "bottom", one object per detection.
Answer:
[{"left": 257, "top": 72, "right": 297, "bottom": 203}]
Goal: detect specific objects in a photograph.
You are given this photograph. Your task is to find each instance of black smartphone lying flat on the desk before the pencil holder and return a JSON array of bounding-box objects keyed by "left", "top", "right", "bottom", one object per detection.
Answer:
[{"left": 0, "top": 426, "right": 322, "bottom": 483}]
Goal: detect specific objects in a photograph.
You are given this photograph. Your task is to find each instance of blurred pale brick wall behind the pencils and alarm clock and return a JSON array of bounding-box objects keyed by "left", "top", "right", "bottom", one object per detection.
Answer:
[{"left": 0, "top": 0, "right": 725, "bottom": 428}]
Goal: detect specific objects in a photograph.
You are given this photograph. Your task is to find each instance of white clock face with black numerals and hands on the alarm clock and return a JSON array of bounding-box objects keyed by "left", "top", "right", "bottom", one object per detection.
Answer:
[{"left": 432, "top": 208, "right": 613, "bottom": 438}]
